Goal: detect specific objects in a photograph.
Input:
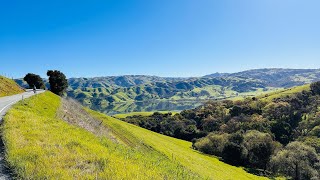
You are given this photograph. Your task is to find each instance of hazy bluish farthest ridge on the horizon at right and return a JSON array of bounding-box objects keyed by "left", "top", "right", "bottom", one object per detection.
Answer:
[{"left": 204, "top": 68, "right": 320, "bottom": 88}]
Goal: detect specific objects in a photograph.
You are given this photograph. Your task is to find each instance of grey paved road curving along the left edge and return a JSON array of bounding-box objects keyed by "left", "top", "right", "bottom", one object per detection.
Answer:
[{"left": 0, "top": 90, "right": 44, "bottom": 180}]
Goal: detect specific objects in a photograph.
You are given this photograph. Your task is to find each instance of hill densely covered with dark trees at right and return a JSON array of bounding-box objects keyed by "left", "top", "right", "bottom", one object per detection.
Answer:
[{"left": 122, "top": 82, "right": 320, "bottom": 179}]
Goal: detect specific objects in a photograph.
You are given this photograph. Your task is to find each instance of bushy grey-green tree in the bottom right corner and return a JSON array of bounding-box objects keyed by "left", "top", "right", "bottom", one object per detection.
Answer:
[{"left": 271, "top": 141, "right": 320, "bottom": 180}]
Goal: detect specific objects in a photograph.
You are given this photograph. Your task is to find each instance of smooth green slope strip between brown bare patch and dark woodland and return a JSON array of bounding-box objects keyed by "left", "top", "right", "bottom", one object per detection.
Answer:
[{"left": 89, "top": 110, "right": 266, "bottom": 179}]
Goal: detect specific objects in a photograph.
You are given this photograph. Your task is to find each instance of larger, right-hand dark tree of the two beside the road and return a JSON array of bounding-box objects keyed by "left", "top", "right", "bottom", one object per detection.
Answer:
[{"left": 47, "top": 70, "right": 68, "bottom": 96}]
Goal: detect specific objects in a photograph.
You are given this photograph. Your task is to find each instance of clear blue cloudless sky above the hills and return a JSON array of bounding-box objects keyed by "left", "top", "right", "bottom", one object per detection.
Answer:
[{"left": 0, "top": 0, "right": 320, "bottom": 78}]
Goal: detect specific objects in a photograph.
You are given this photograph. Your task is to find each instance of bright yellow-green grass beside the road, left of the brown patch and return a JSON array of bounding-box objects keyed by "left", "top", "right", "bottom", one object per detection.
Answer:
[{"left": 2, "top": 92, "right": 200, "bottom": 179}]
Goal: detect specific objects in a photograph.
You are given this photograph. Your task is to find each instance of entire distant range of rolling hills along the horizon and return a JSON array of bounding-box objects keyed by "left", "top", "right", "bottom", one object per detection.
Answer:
[{"left": 16, "top": 68, "right": 320, "bottom": 109}]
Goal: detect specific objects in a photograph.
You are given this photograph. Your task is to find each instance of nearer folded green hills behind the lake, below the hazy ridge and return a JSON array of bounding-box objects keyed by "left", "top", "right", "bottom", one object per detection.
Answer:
[{"left": 68, "top": 78, "right": 269, "bottom": 106}]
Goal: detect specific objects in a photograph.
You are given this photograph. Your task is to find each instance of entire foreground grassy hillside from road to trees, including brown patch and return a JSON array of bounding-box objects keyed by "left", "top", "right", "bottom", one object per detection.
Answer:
[{"left": 3, "top": 92, "right": 263, "bottom": 179}]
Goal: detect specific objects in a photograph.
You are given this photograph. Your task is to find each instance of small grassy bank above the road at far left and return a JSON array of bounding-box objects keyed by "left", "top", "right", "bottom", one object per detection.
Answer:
[{"left": 0, "top": 76, "right": 24, "bottom": 97}]
